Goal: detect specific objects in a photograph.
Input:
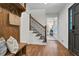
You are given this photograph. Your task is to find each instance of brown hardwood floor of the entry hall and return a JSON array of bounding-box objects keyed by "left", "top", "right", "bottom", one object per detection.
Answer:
[{"left": 26, "top": 40, "right": 72, "bottom": 56}]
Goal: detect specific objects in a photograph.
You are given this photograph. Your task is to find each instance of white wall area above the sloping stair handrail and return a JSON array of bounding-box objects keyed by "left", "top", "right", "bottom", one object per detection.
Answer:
[{"left": 29, "top": 9, "right": 46, "bottom": 26}]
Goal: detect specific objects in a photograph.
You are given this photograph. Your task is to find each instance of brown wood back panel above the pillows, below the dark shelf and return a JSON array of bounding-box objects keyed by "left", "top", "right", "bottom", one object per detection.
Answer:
[{"left": 0, "top": 12, "right": 20, "bottom": 42}]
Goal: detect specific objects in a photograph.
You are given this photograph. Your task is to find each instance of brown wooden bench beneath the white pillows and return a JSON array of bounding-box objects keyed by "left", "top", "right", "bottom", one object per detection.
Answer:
[{"left": 5, "top": 43, "right": 26, "bottom": 56}]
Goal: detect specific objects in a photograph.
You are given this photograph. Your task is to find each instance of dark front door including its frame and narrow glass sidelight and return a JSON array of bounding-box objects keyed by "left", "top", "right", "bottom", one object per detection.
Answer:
[{"left": 69, "top": 3, "right": 79, "bottom": 55}]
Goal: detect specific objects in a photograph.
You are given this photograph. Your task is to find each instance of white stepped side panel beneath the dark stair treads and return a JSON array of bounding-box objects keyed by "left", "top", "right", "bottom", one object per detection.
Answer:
[{"left": 29, "top": 31, "right": 45, "bottom": 45}]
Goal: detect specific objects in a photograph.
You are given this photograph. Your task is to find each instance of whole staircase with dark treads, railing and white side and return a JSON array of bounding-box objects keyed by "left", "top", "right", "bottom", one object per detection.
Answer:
[{"left": 29, "top": 14, "right": 47, "bottom": 45}]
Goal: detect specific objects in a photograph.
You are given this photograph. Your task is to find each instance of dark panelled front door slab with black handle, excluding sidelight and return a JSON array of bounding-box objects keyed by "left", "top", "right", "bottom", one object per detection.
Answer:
[{"left": 73, "top": 4, "right": 79, "bottom": 55}]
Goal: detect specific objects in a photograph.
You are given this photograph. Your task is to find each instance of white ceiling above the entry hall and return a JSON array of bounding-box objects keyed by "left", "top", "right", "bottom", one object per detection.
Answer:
[{"left": 27, "top": 3, "right": 68, "bottom": 14}]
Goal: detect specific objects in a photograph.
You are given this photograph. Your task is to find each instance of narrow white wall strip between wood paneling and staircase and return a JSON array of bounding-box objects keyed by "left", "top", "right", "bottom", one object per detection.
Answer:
[{"left": 20, "top": 12, "right": 29, "bottom": 43}]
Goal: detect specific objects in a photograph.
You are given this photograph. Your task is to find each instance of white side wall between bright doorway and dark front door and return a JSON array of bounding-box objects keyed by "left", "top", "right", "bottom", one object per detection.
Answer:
[{"left": 58, "top": 4, "right": 72, "bottom": 48}]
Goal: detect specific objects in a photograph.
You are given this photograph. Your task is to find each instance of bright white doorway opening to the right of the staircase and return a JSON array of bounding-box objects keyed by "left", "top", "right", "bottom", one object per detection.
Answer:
[{"left": 47, "top": 17, "right": 57, "bottom": 40}]
